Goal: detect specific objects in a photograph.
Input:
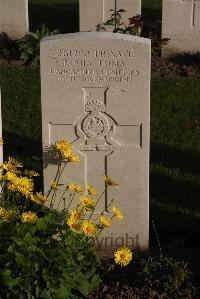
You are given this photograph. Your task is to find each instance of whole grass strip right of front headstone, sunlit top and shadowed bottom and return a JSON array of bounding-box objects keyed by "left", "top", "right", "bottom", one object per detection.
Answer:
[{"left": 150, "top": 78, "right": 200, "bottom": 274}]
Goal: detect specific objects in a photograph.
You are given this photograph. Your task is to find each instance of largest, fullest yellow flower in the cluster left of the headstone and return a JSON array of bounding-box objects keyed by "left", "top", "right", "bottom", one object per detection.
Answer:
[{"left": 13, "top": 177, "right": 34, "bottom": 197}]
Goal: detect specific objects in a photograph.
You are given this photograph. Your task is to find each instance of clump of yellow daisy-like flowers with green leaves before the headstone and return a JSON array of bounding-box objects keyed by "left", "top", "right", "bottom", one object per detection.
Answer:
[{"left": 0, "top": 140, "right": 129, "bottom": 299}]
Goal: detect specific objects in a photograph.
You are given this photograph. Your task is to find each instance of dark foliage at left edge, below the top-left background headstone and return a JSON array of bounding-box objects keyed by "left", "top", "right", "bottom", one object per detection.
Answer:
[{"left": 0, "top": 32, "right": 19, "bottom": 60}]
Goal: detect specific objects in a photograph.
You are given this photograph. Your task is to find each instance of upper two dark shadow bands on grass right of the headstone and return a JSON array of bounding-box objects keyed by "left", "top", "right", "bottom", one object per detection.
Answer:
[{"left": 150, "top": 144, "right": 200, "bottom": 212}]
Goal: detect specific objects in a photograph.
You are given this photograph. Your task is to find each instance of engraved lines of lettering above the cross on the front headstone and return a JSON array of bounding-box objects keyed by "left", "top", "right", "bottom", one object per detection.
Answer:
[{"left": 49, "top": 48, "right": 140, "bottom": 84}]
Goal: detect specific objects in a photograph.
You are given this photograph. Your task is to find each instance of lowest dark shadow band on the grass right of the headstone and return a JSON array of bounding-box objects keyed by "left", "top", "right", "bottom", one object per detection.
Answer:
[{"left": 150, "top": 199, "right": 200, "bottom": 281}]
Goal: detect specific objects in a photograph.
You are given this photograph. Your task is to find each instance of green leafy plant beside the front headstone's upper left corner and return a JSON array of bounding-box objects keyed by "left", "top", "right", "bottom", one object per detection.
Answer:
[{"left": 19, "top": 25, "right": 59, "bottom": 64}]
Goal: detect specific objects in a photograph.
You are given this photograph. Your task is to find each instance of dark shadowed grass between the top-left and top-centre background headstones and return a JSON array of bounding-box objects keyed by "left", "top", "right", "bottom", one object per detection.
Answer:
[{"left": 29, "top": 2, "right": 79, "bottom": 33}]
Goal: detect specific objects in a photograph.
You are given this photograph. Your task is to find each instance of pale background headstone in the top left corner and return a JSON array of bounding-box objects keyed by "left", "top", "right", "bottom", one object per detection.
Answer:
[{"left": 0, "top": 0, "right": 29, "bottom": 39}]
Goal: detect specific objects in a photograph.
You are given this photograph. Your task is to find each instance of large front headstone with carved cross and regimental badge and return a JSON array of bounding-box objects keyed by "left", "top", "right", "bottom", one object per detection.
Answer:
[{"left": 41, "top": 32, "right": 151, "bottom": 254}]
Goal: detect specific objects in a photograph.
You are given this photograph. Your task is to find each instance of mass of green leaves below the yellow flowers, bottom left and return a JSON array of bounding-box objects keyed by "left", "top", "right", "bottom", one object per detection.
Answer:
[{"left": 0, "top": 206, "right": 100, "bottom": 299}]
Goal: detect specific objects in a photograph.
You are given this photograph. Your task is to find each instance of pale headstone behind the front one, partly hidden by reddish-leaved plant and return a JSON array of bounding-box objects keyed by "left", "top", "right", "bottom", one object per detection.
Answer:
[{"left": 79, "top": 0, "right": 141, "bottom": 31}]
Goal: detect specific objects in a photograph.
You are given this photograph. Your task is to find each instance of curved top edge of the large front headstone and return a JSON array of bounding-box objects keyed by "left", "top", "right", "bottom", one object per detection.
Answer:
[{"left": 41, "top": 32, "right": 151, "bottom": 45}]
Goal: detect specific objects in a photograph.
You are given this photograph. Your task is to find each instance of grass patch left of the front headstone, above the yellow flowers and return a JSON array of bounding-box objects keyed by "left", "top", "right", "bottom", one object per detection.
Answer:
[{"left": 0, "top": 66, "right": 42, "bottom": 188}]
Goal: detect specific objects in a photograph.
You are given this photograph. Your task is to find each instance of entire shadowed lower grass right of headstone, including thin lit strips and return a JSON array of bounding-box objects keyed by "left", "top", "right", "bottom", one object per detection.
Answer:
[{"left": 150, "top": 143, "right": 200, "bottom": 276}]
